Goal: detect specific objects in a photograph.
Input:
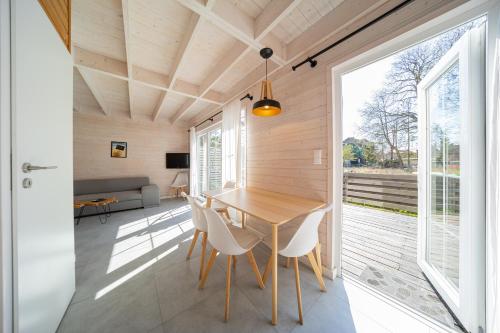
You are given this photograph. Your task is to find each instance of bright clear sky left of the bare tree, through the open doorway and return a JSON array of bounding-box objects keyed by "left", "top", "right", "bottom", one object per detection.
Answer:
[{"left": 342, "top": 55, "right": 395, "bottom": 139}]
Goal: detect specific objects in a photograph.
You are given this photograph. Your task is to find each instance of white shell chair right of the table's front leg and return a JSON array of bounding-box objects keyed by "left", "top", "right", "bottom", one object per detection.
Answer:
[{"left": 262, "top": 205, "right": 333, "bottom": 324}]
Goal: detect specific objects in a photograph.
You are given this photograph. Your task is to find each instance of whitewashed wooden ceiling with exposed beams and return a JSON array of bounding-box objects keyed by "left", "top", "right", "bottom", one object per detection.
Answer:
[{"left": 72, "top": 0, "right": 394, "bottom": 123}]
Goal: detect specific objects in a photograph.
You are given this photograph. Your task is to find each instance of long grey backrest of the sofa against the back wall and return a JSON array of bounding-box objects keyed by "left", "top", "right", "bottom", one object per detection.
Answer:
[{"left": 73, "top": 177, "right": 149, "bottom": 196}]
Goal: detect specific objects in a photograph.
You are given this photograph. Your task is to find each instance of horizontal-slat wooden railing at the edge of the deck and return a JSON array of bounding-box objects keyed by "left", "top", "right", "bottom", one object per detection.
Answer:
[{"left": 344, "top": 172, "right": 418, "bottom": 213}]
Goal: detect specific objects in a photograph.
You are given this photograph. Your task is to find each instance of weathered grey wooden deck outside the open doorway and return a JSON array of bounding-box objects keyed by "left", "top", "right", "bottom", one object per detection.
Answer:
[{"left": 342, "top": 203, "right": 454, "bottom": 327}]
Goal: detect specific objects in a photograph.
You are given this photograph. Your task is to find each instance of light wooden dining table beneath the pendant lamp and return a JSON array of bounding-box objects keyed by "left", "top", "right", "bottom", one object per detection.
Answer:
[{"left": 204, "top": 187, "right": 325, "bottom": 325}]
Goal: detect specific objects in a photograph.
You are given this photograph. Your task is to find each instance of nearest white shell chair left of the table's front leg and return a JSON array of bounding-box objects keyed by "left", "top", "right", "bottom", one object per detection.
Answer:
[{"left": 199, "top": 208, "right": 264, "bottom": 321}]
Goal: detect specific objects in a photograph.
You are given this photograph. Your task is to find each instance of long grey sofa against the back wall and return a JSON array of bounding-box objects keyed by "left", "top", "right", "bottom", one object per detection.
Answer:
[{"left": 73, "top": 177, "right": 160, "bottom": 216}]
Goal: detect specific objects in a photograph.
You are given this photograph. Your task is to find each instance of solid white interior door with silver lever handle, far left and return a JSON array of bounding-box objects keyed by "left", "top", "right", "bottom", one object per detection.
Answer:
[{"left": 11, "top": 0, "right": 75, "bottom": 333}]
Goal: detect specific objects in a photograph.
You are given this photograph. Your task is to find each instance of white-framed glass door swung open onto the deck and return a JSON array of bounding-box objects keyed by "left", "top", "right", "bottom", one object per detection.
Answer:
[{"left": 418, "top": 27, "right": 485, "bottom": 332}]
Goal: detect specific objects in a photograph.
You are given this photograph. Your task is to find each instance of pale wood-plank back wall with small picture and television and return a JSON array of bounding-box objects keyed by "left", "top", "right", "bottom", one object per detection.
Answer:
[{"left": 73, "top": 113, "right": 189, "bottom": 196}]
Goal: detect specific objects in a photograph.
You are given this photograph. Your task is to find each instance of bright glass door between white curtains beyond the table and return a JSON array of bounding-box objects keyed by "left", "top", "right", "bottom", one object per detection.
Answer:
[{"left": 197, "top": 126, "right": 222, "bottom": 193}]
